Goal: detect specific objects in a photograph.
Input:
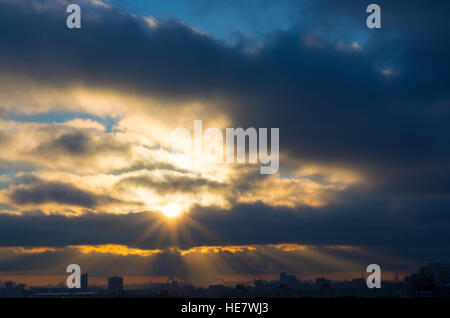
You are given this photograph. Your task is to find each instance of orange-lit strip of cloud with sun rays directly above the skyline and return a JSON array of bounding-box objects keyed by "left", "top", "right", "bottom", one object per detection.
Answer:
[{"left": 0, "top": 245, "right": 415, "bottom": 286}]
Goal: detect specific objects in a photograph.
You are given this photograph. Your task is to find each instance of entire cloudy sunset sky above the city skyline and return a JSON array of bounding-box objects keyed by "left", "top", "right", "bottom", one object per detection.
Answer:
[{"left": 0, "top": 0, "right": 450, "bottom": 285}]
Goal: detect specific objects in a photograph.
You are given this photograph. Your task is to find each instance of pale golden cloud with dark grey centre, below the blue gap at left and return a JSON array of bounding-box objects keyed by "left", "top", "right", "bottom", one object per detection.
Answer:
[{"left": 0, "top": 119, "right": 135, "bottom": 172}]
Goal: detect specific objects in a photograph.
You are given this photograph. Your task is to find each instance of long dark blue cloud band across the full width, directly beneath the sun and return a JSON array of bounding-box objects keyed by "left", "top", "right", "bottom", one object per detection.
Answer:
[{"left": 0, "top": 193, "right": 450, "bottom": 261}]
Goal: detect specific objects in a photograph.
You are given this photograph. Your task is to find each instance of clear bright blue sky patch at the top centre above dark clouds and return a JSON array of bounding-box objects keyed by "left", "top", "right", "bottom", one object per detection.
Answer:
[{"left": 112, "top": 0, "right": 304, "bottom": 45}]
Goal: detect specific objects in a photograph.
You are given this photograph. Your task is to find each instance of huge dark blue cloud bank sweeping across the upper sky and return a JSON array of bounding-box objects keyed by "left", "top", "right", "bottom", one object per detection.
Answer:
[{"left": 0, "top": 1, "right": 450, "bottom": 199}]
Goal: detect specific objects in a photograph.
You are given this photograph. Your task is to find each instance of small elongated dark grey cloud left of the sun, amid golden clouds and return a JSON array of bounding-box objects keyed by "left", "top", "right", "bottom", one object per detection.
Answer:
[{"left": 9, "top": 177, "right": 121, "bottom": 208}]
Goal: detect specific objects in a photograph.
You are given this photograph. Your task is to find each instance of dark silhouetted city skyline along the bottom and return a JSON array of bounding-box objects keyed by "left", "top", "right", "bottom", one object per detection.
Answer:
[{"left": 0, "top": 263, "right": 450, "bottom": 298}]
